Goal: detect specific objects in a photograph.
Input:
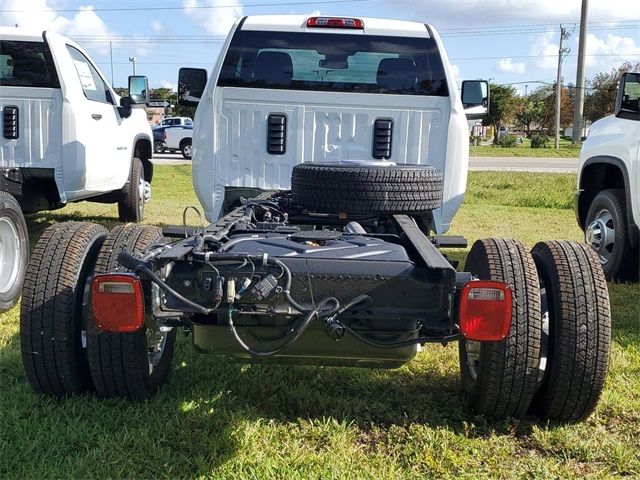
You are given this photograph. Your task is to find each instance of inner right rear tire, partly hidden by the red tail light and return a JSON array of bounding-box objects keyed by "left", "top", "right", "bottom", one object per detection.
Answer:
[{"left": 459, "top": 238, "right": 542, "bottom": 418}]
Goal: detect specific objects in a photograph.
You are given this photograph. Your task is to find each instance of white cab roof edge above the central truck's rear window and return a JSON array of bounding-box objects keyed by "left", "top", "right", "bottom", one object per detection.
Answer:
[{"left": 239, "top": 15, "right": 432, "bottom": 38}]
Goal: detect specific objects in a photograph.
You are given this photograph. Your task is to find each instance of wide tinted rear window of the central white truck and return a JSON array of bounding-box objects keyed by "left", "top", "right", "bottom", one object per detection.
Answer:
[{"left": 218, "top": 31, "right": 449, "bottom": 96}]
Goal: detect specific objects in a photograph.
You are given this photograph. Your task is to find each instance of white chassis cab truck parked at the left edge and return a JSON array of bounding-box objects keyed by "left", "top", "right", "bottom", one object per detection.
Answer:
[{"left": 0, "top": 27, "right": 153, "bottom": 309}]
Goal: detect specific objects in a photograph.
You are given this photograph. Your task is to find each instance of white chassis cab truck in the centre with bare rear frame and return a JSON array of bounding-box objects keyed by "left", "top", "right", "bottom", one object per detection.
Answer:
[{"left": 21, "top": 15, "right": 610, "bottom": 421}]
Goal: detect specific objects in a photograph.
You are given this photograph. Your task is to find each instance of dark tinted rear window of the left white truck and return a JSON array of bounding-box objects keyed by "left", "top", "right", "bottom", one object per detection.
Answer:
[{"left": 0, "top": 40, "right": 60, "bottom": 88}]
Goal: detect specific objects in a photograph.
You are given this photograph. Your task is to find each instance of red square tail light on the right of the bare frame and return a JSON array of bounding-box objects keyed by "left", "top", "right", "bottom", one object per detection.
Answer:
[{"left": 459, "top": 280, "right": 512, "bottom": 342}]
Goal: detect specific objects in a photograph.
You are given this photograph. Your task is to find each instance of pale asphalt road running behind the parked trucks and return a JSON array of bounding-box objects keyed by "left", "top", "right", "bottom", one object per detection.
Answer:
[{"left": 153, "top": 153, "right": 578, "bottom": 173}]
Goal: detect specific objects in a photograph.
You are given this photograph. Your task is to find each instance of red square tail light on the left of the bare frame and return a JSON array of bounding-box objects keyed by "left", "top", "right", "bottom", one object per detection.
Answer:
[{"left": 91, "top": 273, "right": 144, "bottom": 332}]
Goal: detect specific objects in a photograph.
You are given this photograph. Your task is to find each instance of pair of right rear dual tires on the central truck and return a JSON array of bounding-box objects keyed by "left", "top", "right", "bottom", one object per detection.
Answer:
[{"left": 459, "top": 239, "right": 611, "bottom": 422}]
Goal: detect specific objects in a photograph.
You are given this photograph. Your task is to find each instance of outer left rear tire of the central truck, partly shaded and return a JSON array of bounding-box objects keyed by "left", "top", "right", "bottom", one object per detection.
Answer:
[{"left": 20, "top": 222, "right": 107, "bottom": 397}]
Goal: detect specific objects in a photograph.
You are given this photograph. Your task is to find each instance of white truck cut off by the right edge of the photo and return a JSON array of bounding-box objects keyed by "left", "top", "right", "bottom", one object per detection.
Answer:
[{"left": 575, "top": 73, "right": 640, "bottom": 281}]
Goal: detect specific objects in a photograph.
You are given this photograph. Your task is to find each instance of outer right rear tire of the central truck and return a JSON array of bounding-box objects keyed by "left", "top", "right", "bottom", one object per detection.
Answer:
[{"left": 531, "top": 241, "right": 611, "bottom": 422}]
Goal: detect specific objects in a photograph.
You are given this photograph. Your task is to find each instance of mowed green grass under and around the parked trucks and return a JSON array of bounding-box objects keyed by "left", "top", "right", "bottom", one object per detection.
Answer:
[{"left": 0, "top": 167, "right": 640, "bottom": 479}]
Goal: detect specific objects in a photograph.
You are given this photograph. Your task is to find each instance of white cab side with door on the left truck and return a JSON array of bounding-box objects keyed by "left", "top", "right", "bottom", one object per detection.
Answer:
[{"left": 46, "top": 34, "right": 132, "bottom": 196}]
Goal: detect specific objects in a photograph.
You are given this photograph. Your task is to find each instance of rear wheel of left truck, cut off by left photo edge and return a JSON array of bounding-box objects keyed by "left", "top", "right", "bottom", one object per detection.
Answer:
[{"left": 0, "top": 192, "right": 29, "bottom": 311}]
